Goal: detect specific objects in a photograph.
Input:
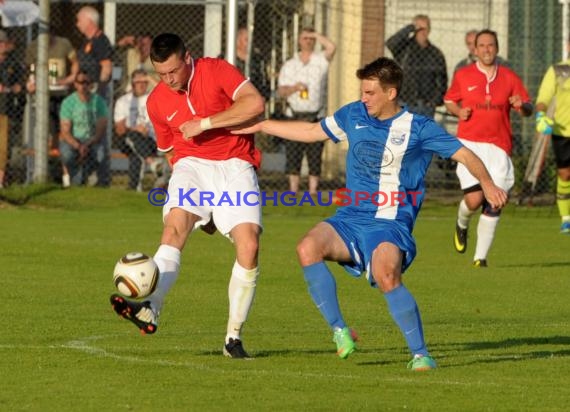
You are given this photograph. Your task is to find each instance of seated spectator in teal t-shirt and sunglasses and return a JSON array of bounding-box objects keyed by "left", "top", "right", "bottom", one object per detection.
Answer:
[{"left": 59, "top": 69, "right": 108, "bottom": 187}]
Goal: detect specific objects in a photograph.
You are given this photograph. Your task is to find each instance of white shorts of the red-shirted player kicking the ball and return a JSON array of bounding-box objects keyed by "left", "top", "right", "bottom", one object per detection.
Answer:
[{"left": 162, "top": 157, "right": 262, "bottom": 237}]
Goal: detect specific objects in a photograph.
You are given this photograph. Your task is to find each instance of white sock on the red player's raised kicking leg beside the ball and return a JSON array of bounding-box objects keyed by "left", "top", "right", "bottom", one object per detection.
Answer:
[{"left": 149, "top": 245, "right": 180, "bottom": 312}]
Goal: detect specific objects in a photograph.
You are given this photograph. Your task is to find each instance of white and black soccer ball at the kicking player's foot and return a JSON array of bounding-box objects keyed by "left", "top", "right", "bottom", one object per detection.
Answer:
[{"left": 113, "top": 252, "right": 159, "bottom": 298}]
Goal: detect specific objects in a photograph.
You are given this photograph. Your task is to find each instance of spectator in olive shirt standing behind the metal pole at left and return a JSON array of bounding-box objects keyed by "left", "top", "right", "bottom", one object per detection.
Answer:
[{"left": 25, "top": 29, "right": 79, "bottom": 153}]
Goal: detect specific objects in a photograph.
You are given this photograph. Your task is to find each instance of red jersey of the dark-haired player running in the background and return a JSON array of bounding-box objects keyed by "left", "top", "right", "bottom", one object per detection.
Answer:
[{"left": 444, "top": 63, "right": 530, "bottom": 156}]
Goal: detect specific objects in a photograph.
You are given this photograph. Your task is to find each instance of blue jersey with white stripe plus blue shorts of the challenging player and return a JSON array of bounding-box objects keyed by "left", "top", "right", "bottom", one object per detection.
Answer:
[{"left": 321, "top": 102, "right": 462, "bottom": 280}]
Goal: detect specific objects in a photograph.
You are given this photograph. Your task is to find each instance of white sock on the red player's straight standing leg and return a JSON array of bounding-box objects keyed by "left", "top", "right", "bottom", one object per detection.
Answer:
[{"left": 226, "top": 261, "right": 259, "bottom": 343}]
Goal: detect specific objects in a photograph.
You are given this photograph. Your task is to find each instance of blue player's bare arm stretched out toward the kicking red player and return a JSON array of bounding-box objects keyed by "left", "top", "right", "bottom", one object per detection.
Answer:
[{"left": 232, "top": 120, "right": 328, "bottom": 143}]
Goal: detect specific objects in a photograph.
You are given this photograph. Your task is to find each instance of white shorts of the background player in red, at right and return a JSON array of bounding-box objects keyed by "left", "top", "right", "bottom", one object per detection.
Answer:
[{"left": 457, "top": 139, "right": 515, "bottom": 191}]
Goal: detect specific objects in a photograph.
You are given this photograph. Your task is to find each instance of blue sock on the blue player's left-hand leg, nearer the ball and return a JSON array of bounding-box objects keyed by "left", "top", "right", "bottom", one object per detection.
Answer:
[{"left": 303, "top": 262, "right": 346, "bottom": 330}]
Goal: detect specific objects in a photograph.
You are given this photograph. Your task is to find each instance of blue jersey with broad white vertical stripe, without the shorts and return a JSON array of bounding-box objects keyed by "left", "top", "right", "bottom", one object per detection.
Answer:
[{"left": 321, "top": 102, "right": 462, "bottom": 232}]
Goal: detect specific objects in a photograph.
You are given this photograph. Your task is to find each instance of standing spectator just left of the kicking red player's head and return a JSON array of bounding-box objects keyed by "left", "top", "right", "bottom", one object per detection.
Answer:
[{"left": 117, "top": 33, "right": 160, "bottom": 93}]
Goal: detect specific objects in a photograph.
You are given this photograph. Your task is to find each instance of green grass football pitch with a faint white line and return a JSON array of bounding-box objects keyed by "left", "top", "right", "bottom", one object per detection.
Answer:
[{"left": 0, "top": 189, "right": 570, "bottom": 411}]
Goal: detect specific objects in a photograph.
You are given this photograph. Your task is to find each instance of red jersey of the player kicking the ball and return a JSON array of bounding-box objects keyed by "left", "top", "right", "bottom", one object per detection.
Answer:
[{"left": 147, "top": 58, "right": 261, "bottom": 168}]
